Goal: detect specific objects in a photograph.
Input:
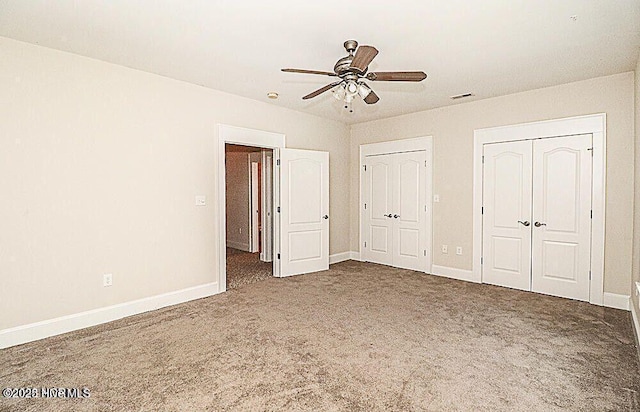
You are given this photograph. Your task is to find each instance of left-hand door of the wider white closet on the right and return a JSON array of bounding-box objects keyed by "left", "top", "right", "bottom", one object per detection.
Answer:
[{"left": 482, "top": 141, "right": 532, "bottom": 290}]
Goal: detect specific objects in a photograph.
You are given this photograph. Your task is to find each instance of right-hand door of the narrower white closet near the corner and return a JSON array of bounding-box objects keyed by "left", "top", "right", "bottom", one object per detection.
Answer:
[{"left": 392, "top": 151, "right": 427, "bottom": 272}]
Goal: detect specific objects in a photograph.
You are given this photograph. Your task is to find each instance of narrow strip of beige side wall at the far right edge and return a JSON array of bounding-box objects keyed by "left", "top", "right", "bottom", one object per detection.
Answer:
[{"left": 631, "top": 56, "right": 640, "bottom": 312}]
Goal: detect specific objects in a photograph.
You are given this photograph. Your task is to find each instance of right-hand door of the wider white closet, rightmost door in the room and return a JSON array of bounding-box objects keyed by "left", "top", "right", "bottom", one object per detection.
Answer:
[{"left": 532, "top": 135, "right": 592, "bottom": 301}]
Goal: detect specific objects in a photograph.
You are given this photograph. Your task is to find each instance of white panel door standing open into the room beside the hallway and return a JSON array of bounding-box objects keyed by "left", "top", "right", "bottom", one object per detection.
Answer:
[{"left": 279, "top": 149, "right": 329, "bottom": 277}]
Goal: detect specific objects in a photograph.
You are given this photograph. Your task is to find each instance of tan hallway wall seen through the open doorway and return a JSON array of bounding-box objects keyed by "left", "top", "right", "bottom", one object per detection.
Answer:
[{"left": 225, "top": 152, "right": 251, "bottom": 251}]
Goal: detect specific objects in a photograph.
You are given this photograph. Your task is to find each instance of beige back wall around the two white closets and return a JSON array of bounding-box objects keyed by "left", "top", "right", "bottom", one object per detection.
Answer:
[{"left": 350, "top": 72, "right": 634, "bottom": 295}]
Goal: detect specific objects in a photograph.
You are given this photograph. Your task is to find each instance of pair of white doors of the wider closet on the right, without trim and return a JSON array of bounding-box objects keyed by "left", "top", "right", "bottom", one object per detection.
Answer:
[{"left": 482, "top": 134, "right": 592, "bottom": 301}]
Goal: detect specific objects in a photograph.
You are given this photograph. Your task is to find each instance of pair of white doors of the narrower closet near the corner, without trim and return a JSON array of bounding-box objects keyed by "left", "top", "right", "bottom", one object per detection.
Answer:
[{"left": 362, "top": 150, "right": 427, "bottom": 272}]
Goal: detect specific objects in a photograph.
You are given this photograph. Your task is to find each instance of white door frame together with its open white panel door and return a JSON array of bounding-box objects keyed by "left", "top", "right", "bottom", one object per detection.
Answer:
[{"left": 217, "top": 125, "right": 330, "bottom": 292}]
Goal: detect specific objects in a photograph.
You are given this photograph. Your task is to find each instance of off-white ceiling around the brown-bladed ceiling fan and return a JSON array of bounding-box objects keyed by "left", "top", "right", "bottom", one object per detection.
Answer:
[{"left": 0, "top": 0, "right": 640, "bottom": 124}]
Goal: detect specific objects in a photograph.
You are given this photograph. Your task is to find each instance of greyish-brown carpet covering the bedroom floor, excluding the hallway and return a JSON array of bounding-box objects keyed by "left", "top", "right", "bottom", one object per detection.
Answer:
[{"left": 0, "top": 261, "right": 640, "bottom": 411}]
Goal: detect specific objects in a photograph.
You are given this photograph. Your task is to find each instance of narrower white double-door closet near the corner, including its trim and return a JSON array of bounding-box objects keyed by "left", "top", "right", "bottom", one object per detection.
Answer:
[{"left": 360, "top": 137, "right": 433, "bottom": 272}]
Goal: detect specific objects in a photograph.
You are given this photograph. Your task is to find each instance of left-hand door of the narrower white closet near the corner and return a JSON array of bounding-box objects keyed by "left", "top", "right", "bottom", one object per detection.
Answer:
[{"left": 362, "top": 155, "right": 393, "bottom": 265}]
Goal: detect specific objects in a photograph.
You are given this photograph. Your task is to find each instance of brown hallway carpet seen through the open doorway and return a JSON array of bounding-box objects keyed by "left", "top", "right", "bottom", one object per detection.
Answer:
[{"left": 227, "top": 247, "right": 273, "bottom": 290}]
